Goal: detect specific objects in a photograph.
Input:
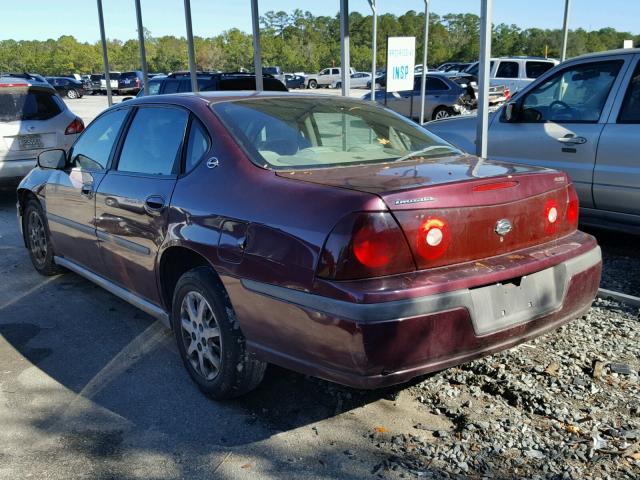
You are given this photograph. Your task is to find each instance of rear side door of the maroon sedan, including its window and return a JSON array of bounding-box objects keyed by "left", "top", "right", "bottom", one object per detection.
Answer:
[{"left": 96, "top": 106, "right": 189, "bottom": 303}]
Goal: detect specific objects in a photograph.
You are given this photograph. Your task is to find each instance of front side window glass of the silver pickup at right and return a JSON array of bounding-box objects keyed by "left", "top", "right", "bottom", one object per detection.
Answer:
[{"left": 521, "top": 60, "right": 622, "bottom": 123}]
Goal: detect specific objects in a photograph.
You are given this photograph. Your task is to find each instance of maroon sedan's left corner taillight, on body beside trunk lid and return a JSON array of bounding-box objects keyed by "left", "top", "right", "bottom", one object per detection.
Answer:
[{"left": 318, "top": 212, "right": 415, "bottom": 280}]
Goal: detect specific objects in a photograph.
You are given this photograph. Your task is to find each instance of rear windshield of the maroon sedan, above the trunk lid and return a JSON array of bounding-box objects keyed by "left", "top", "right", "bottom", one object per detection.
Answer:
[{"left": 213, "top": 97, "right": 461, "bottom": 170}]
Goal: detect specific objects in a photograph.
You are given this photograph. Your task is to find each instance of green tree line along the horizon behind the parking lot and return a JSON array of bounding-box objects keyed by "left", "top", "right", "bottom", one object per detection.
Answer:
[{"left": 0, "top": 10, "right": 640, "bottom": 75}]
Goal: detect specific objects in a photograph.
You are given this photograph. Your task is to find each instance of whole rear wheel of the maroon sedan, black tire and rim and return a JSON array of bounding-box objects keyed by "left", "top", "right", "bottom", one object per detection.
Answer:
[{"left": 171, "top": 267, "right": 267, "bottom": 400}]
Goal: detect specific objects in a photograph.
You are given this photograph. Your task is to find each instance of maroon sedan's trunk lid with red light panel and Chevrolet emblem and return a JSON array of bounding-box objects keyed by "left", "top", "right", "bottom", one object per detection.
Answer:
[{"left": 278, "top": 156, "right": 577, "bottom": 269}]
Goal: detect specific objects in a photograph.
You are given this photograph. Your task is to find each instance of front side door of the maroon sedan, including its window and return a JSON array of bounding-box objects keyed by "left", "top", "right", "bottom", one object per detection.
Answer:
[{"left": 45, "top": 109, "right": 129, "bottom": 272}]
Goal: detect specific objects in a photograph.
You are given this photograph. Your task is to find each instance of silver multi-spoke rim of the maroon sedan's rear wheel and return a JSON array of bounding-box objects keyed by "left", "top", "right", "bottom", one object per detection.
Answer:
[{"left": 180, "top": 291, "right": 222, "bottom": 381}]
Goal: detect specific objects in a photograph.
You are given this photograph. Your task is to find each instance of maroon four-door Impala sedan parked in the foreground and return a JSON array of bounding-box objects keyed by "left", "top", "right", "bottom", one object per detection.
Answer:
[{"left": 18, "top": 92, "right": 601, "bottom": 398}]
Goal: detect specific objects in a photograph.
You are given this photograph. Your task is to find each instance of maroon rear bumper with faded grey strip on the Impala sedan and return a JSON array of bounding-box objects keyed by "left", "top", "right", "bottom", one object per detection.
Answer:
[{"left": 228, "top": 234, "right": 602, "bottom": 388}]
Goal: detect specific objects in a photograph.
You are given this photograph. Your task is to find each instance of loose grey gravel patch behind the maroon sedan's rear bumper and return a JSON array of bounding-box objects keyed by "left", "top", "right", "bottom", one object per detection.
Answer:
[{"left": 340, "top": 299, "right": 640, "bottom": 480}]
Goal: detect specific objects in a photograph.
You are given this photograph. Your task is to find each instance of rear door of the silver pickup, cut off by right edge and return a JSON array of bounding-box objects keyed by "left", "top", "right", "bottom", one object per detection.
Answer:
[{"left": 593, "top": 55, "right": 640, "bottom": 215}]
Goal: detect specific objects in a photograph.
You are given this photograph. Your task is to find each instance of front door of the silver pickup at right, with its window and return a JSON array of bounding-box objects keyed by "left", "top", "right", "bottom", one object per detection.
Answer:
[{"left": 489, "top": 55, "right": 628, "bottom": 207}]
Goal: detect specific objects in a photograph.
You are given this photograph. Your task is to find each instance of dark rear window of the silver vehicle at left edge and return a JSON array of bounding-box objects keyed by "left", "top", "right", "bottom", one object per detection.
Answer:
[{"left": 0, "top": 88, "right": 64, "bottom": 122}]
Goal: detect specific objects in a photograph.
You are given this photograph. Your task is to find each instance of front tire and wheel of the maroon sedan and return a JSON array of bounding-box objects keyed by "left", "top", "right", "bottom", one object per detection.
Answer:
[{"left": 22, "top": 198, "right": 65, "bottom": 277}]
